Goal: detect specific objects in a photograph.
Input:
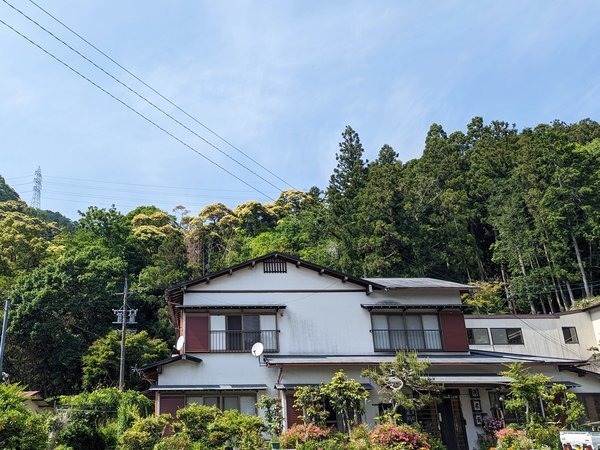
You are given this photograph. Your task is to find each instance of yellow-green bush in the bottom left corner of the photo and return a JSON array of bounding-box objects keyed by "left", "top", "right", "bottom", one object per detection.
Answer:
[{"left": 0, "top": 384, "right": 48, "bottom": 450}]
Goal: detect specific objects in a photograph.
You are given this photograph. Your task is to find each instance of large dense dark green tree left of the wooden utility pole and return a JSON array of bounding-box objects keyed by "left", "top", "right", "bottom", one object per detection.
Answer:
[{"left": 6, "top": 245, "right": 126, "bottom": 395}]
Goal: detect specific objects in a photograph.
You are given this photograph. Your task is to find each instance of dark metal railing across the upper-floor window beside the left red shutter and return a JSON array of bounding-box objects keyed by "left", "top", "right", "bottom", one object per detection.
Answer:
[{"left": 210, "top": 330, "right": 279, "bottom": 353}]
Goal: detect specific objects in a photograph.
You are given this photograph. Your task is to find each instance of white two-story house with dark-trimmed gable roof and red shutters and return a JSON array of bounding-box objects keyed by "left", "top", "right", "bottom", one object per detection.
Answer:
[{"left": 143, "top": 253, "right": 600, "bottom": 450}]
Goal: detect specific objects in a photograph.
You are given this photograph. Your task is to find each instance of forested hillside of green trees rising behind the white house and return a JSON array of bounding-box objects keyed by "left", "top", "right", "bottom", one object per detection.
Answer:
[{"left": 0, "top": 118, "right": 600, "bottom": 395}]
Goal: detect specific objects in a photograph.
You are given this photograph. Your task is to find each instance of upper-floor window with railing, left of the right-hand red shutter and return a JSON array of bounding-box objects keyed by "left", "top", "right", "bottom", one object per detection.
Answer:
[{"left": 371, "top": 314, "right": 442, "bottom": 352}]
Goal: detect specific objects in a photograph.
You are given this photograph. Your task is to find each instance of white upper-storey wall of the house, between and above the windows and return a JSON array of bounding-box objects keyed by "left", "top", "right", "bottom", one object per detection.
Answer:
[{"left": 183, "top": 263, "right": 460, "bottom": 355}]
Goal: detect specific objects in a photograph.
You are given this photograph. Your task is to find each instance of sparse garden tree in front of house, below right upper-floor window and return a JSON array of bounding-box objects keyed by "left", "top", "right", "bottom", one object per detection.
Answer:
[{"left": 361, "top": 352, "right": 444, "bottom": 422}]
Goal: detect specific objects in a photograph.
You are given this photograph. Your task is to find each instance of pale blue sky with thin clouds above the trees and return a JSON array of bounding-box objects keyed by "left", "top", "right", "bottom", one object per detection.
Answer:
[{"left": 0, "top": 0, "right": 600, "bottom": 219}]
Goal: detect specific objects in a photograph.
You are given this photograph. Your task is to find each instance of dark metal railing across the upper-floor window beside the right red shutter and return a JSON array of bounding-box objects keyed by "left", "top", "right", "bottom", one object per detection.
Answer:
[{"left": 371, "top": 330, "right": 442, "bottom": 352}]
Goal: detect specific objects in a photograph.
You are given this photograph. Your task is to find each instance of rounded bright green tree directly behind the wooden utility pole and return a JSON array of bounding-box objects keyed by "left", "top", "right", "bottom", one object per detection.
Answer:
[{"left": 83, "top": 330, "right": 169, "bottom": 390}]
